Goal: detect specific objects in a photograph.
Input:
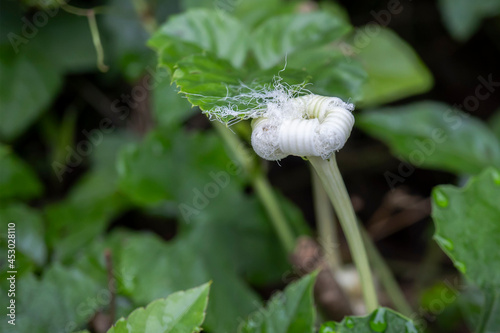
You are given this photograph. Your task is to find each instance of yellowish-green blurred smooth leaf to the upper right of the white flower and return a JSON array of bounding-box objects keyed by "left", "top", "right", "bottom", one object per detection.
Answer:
[{"left": 356, "top": 26, "right": 433, "bottom": 107}]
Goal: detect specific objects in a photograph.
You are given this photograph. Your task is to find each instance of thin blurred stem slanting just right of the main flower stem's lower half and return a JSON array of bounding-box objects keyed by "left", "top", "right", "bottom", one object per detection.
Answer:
[{"left": 360, "top": 226, "right": 413, "bottom": 316}]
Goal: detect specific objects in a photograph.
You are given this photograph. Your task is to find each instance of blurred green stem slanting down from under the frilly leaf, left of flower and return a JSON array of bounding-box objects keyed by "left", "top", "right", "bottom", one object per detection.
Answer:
[{"left": 213, "top": 122, "right": 295, "bottom": 253}]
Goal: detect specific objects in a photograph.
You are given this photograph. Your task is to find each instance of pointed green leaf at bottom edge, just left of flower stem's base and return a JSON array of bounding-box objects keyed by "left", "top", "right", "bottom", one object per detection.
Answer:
[{"left": 239, "top": 272, "right": 317, "bottom": 333}]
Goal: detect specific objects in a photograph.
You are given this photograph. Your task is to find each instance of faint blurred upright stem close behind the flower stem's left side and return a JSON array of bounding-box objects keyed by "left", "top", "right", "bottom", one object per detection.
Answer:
[{"left": 312, "top": 167, "right": 342, "bottom": 276}]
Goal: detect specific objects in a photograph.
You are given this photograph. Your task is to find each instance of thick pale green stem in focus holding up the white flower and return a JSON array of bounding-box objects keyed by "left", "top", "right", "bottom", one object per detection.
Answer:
[{"left": 308, "top": 155, "right": 378, "bottom": 312}]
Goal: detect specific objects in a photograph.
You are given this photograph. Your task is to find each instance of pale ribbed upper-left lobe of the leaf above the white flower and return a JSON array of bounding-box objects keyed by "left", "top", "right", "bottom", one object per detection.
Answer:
[{"left": 149, "top": 9, "right": 249, "bottom": 67}]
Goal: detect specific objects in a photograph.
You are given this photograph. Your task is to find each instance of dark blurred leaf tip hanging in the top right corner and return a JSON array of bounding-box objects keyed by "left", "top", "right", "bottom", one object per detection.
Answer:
[{"left": 438, "top": 0, "right": 500, "bottom": 41}]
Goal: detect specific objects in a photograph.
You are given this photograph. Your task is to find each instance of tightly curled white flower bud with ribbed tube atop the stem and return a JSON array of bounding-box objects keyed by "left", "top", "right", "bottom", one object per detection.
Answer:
[{"left": 252, "top": 94, "right": 354, "bottom": 161}]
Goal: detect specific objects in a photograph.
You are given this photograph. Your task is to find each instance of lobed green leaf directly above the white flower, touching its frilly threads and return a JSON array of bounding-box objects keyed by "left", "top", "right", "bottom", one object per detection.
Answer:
[{"left": 149, "top": 6, "right": 365, "bottom": 118}]
